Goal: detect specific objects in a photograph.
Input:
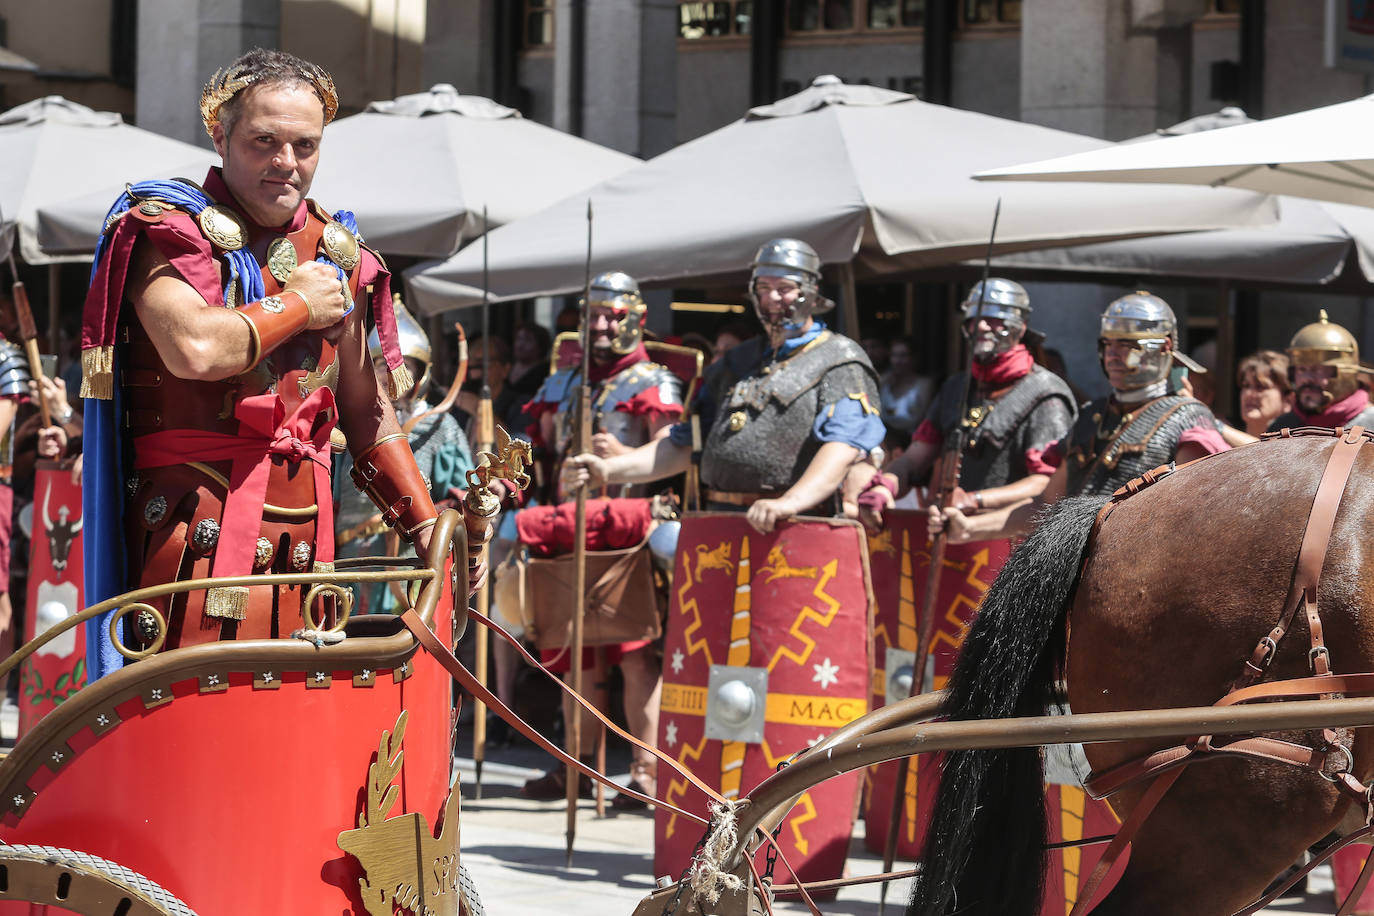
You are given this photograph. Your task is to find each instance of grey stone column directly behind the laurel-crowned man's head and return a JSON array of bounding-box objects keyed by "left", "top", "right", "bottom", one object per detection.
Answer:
[{"left": 135, "top": 0, "right": 282, "bottom": 147}]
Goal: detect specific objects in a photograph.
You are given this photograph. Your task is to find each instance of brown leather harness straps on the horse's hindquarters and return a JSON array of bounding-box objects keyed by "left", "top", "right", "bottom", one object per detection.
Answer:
[{"left": 1070, "top": 426, "right": 1374, "bottom": 916}]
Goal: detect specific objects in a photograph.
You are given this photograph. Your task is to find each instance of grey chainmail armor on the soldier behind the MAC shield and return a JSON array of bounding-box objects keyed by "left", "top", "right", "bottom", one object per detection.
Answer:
[{"left": 701, "top": 331, "right": 878, "bottom": 494}]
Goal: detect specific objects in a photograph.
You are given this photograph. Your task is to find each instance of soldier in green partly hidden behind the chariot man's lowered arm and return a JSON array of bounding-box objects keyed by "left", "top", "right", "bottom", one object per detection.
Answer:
[{"left": 334, "top": 295, "right": 473, "bottom": 614}]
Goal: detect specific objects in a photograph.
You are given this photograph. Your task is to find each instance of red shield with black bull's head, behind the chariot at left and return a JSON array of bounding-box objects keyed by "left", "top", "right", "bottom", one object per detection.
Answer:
[{"left": 19, "top": 460, "right": 85, "bottom": 735}]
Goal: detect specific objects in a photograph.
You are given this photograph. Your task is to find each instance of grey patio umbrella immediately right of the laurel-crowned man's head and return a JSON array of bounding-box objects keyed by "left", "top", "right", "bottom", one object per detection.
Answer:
[{"left": 311, "top": 84, "right": 640, "bottom": 258}]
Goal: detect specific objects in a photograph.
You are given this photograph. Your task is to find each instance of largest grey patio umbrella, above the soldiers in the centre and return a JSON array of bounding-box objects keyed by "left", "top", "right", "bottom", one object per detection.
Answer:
[{"left": 405, "top": 77, "right": 1275, "bottom": 313}]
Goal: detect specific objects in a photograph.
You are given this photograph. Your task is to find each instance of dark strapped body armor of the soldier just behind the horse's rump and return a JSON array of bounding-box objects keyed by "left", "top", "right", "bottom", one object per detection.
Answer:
[{"left": 1063, "top": 394, "right": 1216, "bottom": 496}]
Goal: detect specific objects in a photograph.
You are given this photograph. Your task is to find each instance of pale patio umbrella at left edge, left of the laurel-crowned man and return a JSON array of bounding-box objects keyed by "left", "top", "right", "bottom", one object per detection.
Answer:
[{"left": 0, "top": 96, "right": 218, "bottom": 264}]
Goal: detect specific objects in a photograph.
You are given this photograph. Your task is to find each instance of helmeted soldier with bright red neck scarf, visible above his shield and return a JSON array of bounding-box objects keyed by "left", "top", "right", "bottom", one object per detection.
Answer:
[{"left": 860, "top": 277, "right": 1077, "bottom": 514}]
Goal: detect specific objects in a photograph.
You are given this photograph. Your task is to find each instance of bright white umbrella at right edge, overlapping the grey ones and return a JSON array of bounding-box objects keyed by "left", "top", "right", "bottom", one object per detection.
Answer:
[{"left": 976, "top": 95, "right": 1374, "bottom": 207}]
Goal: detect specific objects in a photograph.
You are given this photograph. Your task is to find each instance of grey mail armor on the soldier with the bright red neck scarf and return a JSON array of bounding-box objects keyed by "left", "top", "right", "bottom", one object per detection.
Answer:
[{"left": 930, "top": 365, "right": 1079, "bottom": 492}]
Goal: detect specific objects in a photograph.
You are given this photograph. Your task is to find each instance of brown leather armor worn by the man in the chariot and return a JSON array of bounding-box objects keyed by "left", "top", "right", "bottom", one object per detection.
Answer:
[{"left": 118, "top": 203, "right": 359, "bottom": 648}]
